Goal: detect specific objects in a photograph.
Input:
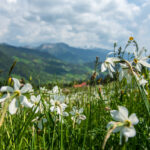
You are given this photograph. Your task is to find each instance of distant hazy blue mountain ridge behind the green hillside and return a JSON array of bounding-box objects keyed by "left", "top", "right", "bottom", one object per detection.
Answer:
[{"left": 33, "top": 43, "right": 110, "bottom": 64}]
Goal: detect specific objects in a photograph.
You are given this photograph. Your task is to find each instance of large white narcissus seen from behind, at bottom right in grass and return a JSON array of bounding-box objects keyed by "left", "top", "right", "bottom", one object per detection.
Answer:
[{"left": 107, "top": 106, "right": 139, "bottom": 144}]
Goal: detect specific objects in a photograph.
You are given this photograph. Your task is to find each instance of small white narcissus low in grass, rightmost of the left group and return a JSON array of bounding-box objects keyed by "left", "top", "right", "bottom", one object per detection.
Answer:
[{"left": 70, "top": 106, "right": 86, "bottom": 124}]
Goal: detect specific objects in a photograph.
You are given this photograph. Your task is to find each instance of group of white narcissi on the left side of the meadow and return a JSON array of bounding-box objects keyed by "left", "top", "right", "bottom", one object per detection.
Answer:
[{"left": 0, "top": 78, "right": 86, "bottom": 129}]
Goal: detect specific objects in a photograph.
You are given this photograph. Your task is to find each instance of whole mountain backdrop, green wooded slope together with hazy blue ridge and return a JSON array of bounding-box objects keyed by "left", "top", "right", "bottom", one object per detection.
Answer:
[{"left": 0, "top": 43, "right": 110, "bottom": 83}]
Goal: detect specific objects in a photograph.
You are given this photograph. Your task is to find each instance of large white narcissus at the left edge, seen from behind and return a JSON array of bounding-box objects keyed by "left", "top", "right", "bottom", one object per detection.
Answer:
[{"left": 0, "top": 78, "right": 32, "bottom": 114}]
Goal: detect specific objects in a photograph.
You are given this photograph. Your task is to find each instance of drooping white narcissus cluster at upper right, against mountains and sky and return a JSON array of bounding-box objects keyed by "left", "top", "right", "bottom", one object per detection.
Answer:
[{"left": 101, "top": 45, "right": 150, "bottom": 86}]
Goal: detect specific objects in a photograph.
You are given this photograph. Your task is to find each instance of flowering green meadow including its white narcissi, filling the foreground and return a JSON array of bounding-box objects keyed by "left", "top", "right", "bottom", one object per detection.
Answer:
[{"left": 0, "top": 39, "right": 150, "bottom": 150}]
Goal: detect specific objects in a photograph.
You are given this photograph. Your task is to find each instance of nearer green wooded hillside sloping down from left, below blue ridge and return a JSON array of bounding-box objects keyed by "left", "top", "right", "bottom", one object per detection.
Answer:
[{"left": 0, "top": 44, "right": 91, "bottom": 82}]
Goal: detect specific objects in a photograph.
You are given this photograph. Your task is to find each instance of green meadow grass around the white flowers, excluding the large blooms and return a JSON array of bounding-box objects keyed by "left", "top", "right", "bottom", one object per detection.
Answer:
[{"left": 0, "top": 78, "right": 150, "bottom": 150}]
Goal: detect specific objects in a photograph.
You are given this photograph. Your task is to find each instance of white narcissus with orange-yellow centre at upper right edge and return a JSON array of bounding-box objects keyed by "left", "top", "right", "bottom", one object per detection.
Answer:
[{"left": 132, "top": 49, "right": 150, "bottom": 72}]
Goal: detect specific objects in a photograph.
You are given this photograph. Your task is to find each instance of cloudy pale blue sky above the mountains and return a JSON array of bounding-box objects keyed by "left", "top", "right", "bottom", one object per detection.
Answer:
[{"left": 0, "top": 0, "right": 150, "bottom": 52}]
